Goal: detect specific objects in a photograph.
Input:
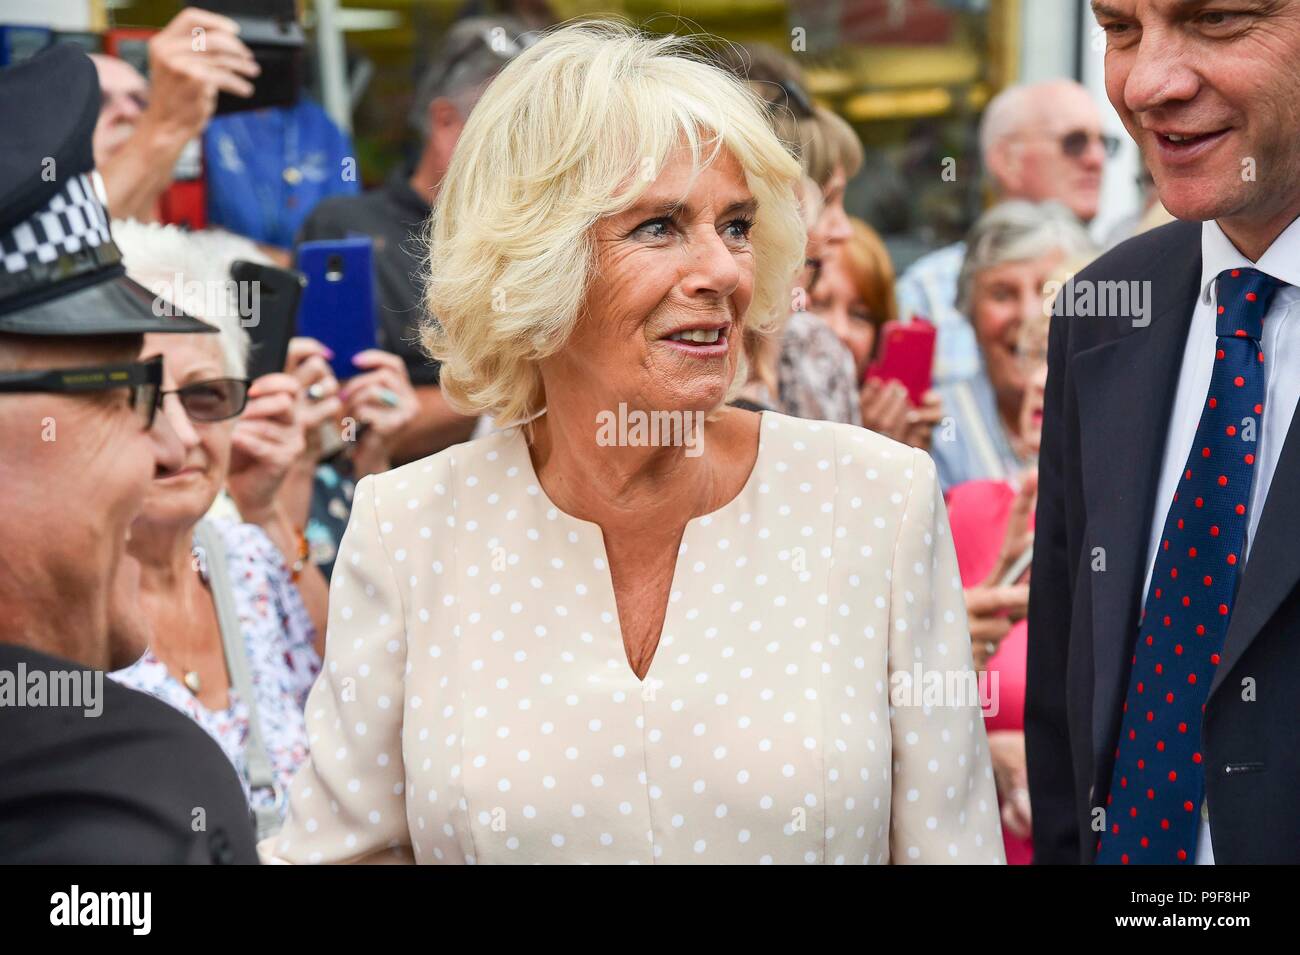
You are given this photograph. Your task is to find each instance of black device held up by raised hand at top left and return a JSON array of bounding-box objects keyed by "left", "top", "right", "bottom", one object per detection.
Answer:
[{"left": 199, "top": 0, "right": 304, "bottom": 116}]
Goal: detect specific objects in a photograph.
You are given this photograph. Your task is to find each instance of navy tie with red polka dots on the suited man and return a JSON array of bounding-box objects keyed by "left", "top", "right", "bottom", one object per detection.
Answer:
[{"left": 1096, "top": 269, "right": 1281, "bottom": 864}]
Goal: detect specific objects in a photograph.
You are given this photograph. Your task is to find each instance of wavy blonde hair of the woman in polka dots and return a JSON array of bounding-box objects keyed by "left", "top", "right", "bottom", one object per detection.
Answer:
[{"left": 421, "top": 21, "right": 805, "bottom": 425}]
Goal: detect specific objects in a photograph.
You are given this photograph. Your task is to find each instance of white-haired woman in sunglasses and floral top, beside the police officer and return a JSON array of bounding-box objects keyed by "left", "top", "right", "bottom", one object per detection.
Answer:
[{"left": 112, "top": 222, "right": 339, "bottom": 833}]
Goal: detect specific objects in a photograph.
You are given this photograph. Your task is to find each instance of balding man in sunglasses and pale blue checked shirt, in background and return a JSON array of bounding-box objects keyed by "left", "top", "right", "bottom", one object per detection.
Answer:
[{"left": 897, "top": 79, "right": 1118, "bottom": 386}]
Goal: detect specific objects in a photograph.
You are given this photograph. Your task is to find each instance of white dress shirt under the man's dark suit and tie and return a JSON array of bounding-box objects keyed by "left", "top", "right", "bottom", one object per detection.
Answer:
[{"left": 1143, "top": 218, "right": 1300, "bottom": 865}]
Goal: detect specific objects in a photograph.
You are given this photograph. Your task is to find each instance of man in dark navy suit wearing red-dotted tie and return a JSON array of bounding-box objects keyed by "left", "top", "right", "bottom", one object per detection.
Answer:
[{"left": 1026, "top": 0, "right": 1300, "bottom": 864}]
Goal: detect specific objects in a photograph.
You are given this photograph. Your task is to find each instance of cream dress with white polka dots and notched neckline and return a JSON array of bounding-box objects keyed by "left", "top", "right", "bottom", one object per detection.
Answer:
[{"left": 261, "top": 413, "right": 1004, "bottom": 864}]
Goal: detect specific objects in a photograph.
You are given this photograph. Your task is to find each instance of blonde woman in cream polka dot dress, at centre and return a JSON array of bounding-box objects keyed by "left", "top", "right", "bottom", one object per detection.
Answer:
[{"left": 263, "top": 23, "right": 1002, "bottom": 863}]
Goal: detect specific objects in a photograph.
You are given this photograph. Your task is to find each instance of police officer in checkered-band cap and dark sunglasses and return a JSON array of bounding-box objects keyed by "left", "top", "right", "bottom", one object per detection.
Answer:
[{"left": 0, "top": 45, "right": 257, "bottom": 863}]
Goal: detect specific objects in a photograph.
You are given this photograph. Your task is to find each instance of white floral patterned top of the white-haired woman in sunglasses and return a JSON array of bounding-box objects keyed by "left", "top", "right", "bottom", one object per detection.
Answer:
[{"left": 109, "top": 518, "right": 321, "bottom": 812}]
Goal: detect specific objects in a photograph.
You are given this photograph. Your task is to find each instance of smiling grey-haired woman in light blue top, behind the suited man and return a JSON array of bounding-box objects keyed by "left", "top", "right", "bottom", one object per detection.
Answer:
[{"left": 930, "top": 199, "right": 1095, "bottom": 491}]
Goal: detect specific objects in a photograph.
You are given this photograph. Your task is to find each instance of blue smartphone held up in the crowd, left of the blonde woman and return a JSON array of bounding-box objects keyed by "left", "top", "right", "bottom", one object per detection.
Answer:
[{"left": 298, "top": 238, "right": 377, "bottom": 381}]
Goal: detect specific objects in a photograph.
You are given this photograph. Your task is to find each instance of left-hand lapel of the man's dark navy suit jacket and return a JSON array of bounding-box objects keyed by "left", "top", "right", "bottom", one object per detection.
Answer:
[{"left": 1071, "top": 230, "right": 1201, "bottom": 768}]
